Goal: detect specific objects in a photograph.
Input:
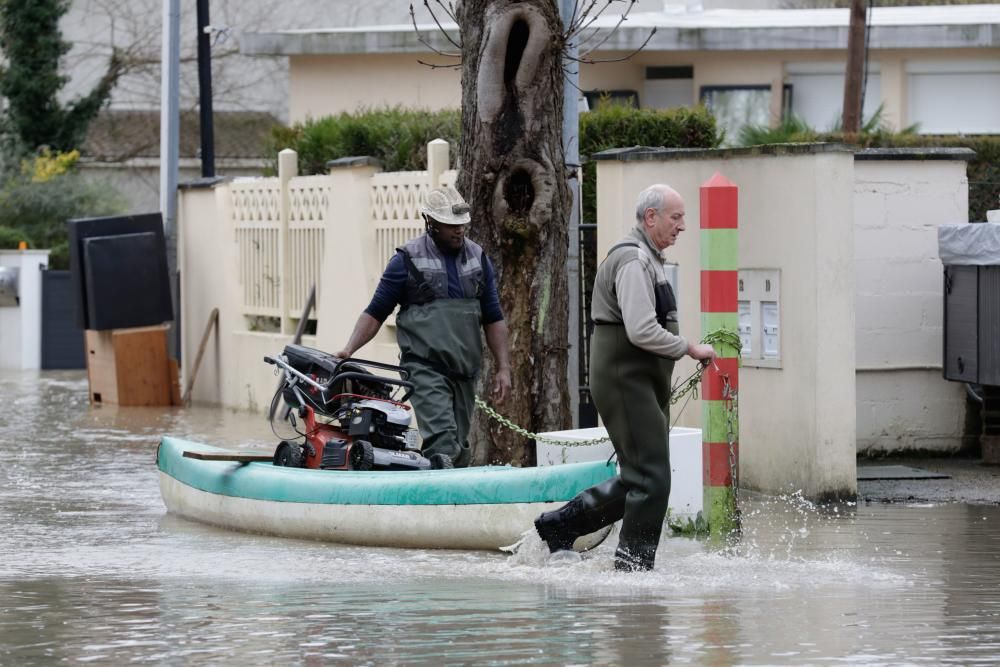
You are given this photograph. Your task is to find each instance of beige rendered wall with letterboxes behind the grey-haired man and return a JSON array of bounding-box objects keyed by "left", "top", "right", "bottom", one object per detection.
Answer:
[{"left": 597, "top": 148, "right": 857, "bottom": 497}]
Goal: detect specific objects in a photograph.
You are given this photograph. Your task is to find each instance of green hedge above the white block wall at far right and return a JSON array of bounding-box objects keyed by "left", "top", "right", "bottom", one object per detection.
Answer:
[{"left": 814, "top": 133, "right": 1000, "bottom": 222}]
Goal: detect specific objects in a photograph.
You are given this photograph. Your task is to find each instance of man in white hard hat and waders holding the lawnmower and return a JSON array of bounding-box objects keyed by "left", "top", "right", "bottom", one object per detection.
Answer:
[{"left": 336, "top": 188, "right": 510, "bottom": 468}]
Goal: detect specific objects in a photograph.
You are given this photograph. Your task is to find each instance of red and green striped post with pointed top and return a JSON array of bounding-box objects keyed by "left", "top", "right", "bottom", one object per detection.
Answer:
[{"left": 700, "top": 173, "right": 740, "bottom": 535}]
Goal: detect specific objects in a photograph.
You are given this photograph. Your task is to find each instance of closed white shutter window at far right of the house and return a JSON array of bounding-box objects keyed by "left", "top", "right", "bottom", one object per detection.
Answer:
[{"left": 906, "top": 60, "right": 1000, "bottom": 134}]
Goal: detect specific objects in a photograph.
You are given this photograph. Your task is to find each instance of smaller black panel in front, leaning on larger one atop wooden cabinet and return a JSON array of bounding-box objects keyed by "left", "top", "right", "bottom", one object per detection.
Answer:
[{"left": 83, "top": 232, "right": 173, "bottom": 330}]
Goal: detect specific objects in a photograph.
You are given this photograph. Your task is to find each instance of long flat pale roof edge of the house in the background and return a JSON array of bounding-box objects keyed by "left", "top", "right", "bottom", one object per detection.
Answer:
[{"left": 240, "top": 4, "right": 1000, "bottom": 56}]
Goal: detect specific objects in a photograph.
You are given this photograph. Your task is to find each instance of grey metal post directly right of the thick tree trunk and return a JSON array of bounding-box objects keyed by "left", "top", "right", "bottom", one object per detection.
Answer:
[{"left": 559, "top": 0, "right": 581, "bottom": 426}]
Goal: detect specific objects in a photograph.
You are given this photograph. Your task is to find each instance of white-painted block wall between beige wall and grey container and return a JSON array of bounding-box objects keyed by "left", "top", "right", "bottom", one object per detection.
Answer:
[{"left": 854, "top": 154, "right": 969, "bottom": 453}]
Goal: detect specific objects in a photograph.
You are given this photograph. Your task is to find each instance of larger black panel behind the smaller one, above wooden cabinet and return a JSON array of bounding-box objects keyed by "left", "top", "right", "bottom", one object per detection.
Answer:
[{"left": 66, "top": 213, "right": 173, "bottom": 329}]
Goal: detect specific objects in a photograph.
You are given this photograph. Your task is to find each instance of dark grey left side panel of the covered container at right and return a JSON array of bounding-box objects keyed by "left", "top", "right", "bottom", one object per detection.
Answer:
[{"left": 944, "top": 266, "right": 979, "bottom": 382}]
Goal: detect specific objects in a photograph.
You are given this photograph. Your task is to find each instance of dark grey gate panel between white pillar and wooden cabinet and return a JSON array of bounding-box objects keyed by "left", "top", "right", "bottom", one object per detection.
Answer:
[{"left": 42, "top": 271, "right": 87, "bottom": 369}]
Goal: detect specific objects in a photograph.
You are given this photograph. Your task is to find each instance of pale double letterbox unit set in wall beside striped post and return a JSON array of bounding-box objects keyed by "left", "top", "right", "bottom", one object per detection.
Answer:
[{"left": 738, "top": 269, "right": 781, "bottom": 368}]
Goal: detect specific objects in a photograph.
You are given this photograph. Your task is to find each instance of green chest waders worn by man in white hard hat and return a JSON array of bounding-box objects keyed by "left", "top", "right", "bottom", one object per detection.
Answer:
[{"left": 396, "top": 299, "right": 483, "bottom": 467}]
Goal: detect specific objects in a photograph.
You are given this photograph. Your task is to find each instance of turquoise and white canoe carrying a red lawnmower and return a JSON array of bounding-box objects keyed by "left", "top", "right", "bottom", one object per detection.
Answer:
[{"left": 156, "top": 437, "right": 617, "bottom": 549}]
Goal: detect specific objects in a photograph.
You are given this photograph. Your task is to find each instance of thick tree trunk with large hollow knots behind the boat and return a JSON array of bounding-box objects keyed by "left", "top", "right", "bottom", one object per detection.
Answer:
[{"left": 457, "top": 0, "right": 571, "bottom": 465}]
